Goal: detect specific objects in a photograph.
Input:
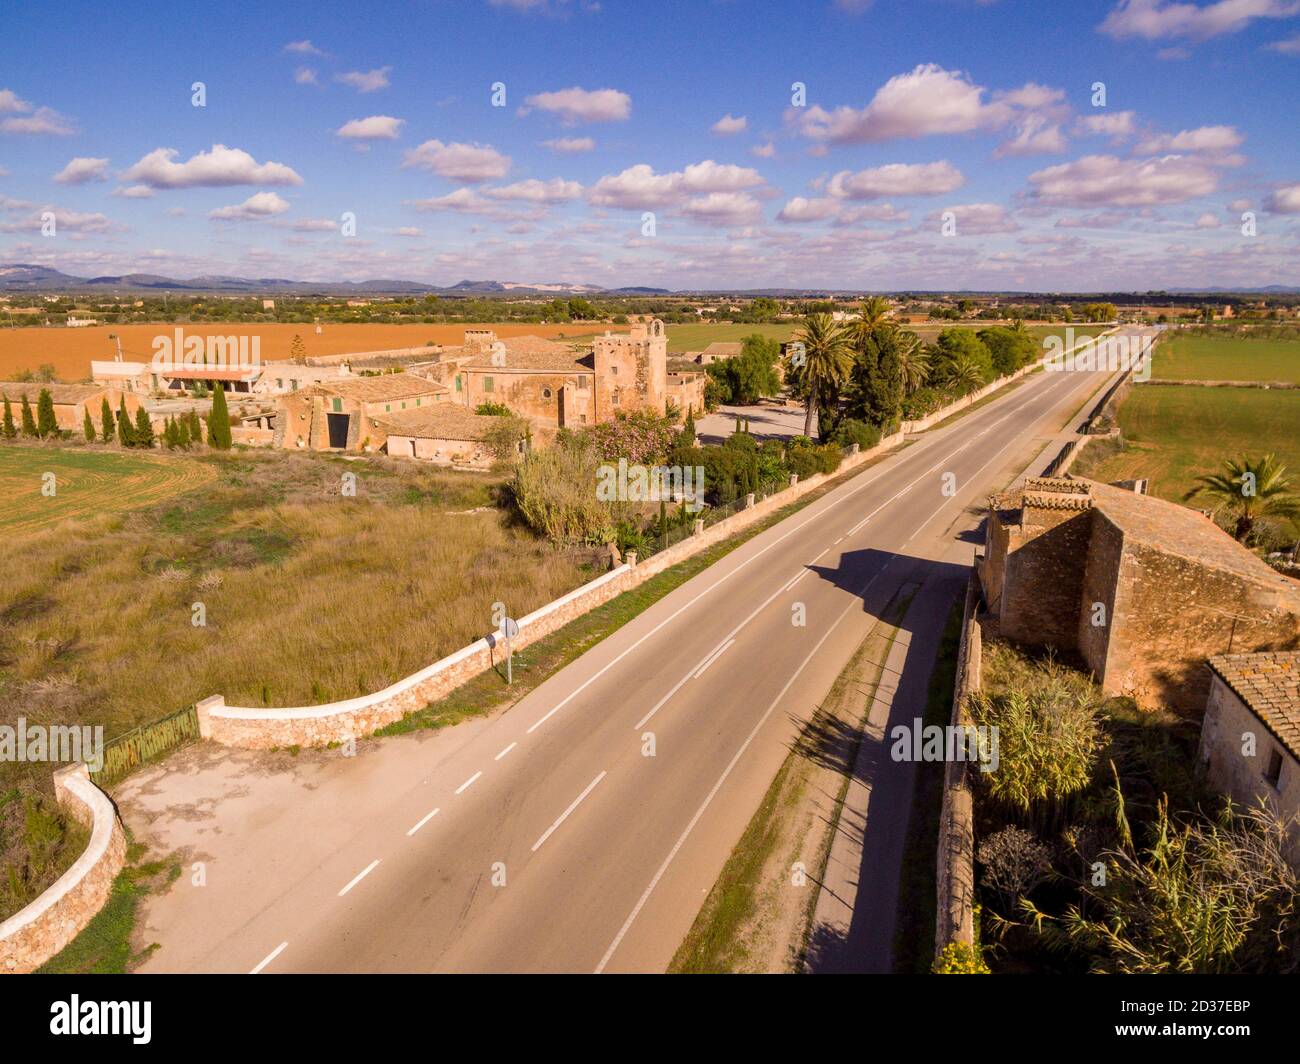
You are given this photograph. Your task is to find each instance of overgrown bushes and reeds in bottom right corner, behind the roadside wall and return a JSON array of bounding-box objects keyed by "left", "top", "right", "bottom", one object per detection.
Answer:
[{"left": 971, "top": 643, "right": 1300, "bottom": 973}]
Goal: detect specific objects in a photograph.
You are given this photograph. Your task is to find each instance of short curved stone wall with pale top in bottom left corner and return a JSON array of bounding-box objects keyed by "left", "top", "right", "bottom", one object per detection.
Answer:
[{"left": 0, "top": 765, "right": 126, "bottom": 974}]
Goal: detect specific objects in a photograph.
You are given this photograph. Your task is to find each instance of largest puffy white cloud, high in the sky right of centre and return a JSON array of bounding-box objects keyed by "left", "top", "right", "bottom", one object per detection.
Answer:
[{"left": 788, "top": 62, "right": 1019, "bottom": 144}]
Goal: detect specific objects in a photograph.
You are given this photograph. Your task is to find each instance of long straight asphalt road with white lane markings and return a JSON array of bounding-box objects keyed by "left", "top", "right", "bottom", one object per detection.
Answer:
[{"left": 122, "top": 338, "right": 1133, "bottom": 973}]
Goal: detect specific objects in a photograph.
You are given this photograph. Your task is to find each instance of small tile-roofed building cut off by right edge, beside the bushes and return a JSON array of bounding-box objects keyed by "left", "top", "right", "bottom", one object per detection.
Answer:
[{"left": 1200, "top": 650, "right": 1300, "bottom": 866}]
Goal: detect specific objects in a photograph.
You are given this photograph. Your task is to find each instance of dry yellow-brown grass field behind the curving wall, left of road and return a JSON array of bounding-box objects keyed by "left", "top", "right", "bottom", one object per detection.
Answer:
[{"left": 0, "top": 447, "right": 595, "bottom": 749}]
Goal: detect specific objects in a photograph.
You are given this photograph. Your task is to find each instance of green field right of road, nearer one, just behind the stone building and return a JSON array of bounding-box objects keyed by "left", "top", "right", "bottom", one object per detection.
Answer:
[{"left": 1080, "top": 382, "right": 1300, "bottom": 528}]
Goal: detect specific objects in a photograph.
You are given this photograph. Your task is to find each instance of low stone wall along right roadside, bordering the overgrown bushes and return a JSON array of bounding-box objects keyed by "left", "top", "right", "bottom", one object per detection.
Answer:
[{"left": 935, "top": 571, "right": 983, "bottom": 960}]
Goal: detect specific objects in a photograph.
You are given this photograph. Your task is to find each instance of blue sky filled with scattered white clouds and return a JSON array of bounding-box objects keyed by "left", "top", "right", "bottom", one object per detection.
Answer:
[{"left": 0, "top": 0, "right": 1300, "bottom": 290}]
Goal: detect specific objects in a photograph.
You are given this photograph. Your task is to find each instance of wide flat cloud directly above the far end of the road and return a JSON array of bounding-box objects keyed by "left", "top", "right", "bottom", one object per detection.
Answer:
[{"left": 1030, "top": 155, "right": 1218, "bottom": 207}]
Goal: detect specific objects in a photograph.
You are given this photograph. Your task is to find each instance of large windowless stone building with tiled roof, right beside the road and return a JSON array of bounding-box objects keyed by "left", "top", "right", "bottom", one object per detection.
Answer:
[{"left": 978, "top": 477, "right": 1300, "bottom": 714}]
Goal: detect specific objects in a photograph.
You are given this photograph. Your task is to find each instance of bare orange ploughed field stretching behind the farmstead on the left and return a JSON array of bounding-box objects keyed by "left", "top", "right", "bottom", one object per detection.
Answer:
[{"left": 0, "top": 323, "right": 629, "bottom": 382}]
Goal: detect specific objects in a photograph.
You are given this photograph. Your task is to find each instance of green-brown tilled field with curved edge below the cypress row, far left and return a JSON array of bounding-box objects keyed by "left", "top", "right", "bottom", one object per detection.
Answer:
[{"left": 0, "top": 445, "right": 216, "bottom": 537}]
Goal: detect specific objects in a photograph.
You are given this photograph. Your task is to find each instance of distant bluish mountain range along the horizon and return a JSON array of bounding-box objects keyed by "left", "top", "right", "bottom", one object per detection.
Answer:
[{"left": 0, "top": 263, "right": 1300, "bottom": 299}]
